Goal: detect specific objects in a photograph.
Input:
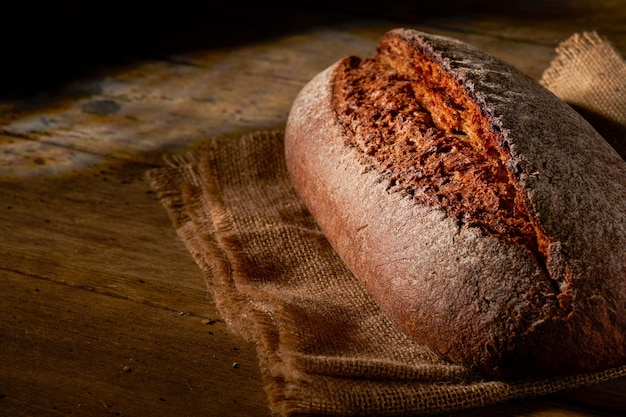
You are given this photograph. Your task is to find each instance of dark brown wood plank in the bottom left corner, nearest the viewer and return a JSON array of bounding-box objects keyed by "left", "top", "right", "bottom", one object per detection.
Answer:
[{"left": 0, "top": 270, "right": 269, "bottom": 417}]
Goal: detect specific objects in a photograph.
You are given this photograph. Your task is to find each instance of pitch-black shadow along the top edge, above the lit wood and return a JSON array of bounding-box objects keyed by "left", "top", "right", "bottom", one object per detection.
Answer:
[{"left": 0, "top": 0, "right": 582, "bottom": 99}]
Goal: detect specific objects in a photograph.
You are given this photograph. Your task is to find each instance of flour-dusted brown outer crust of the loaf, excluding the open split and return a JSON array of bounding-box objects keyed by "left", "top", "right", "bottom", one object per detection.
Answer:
[{"left": 285, "top": 29, "right": 626, "bottom": 376}]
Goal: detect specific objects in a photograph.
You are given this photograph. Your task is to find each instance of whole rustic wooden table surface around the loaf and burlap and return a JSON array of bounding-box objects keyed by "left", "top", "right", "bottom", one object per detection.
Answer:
[{"left": 0, "top": 0, "right": 626, "bottom": 417}]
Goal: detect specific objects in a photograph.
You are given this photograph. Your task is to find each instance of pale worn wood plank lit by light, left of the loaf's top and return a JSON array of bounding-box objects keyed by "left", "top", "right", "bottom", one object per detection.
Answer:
[{"left": 3, "top": 58, "right": 304, "bottom": 164}]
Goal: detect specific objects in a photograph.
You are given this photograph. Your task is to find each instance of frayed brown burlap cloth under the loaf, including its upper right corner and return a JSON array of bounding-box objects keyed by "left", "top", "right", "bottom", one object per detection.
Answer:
[{"left": 147, "top": 33, "right": 626, "bottom": 416}]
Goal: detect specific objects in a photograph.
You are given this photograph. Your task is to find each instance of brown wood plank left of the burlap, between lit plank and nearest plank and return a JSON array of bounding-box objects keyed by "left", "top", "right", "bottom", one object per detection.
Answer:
[{"left": 0, "top": 139, "right": 215, "bottom": 315}]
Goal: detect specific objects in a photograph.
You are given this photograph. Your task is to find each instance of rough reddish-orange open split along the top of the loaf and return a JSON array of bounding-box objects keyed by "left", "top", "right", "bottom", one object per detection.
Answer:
[{"left": 332, "top": 38, "right": 547, "bottom": 262}]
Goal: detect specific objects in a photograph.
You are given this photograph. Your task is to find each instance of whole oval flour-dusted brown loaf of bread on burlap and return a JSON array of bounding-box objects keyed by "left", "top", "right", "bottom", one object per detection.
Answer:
[{"left": 285, "top": 29, "right": 626, "bottom": 377}]
